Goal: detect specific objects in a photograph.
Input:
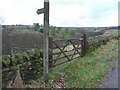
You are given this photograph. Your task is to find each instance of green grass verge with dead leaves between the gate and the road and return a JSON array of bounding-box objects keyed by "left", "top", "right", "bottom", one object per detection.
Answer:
[{"left": 28, "top": 40, "right": 118, "bottom": 88}]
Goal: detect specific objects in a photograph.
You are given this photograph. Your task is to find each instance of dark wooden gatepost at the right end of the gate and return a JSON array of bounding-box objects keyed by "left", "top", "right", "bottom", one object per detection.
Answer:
[{"left": 81, "top": 34, "right": 88, "bottom": 57}]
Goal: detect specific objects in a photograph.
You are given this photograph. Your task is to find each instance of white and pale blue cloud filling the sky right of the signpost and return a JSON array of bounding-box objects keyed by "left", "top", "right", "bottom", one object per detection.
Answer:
[{"left": 51, "top": 0, "right": 118, "bottom": 27}]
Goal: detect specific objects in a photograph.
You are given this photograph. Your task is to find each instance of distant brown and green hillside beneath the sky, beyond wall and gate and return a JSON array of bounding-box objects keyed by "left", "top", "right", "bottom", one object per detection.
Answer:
[{"left": 2, "top": 25, "right": 118, "bottom": 54}]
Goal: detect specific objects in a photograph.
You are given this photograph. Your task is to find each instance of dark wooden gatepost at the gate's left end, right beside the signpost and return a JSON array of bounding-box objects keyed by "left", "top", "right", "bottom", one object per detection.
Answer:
[{"left": 49, "top": 37, "right": 53, "bottom": 67}]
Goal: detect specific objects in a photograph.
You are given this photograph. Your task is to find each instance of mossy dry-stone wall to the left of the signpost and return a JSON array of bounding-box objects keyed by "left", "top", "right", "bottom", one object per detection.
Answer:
[{"left": 2, "top": 49, "right": 43, "bottom": 87}]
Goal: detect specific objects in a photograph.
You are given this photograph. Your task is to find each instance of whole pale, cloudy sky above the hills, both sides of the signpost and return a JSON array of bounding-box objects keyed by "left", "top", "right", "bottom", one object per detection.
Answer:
[{"left": 0, "top": 0, "right": 119, "bottom": 27}]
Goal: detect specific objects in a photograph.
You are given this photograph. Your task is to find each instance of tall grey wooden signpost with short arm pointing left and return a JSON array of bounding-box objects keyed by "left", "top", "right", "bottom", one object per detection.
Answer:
[{"left": 36, "top": 0, "right": 49, "bottom": 80}]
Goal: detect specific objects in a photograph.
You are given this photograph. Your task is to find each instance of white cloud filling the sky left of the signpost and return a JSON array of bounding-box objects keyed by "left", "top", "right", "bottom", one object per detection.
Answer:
[{"left": 0, "top": 0, "right": 43, "bottom": 24}]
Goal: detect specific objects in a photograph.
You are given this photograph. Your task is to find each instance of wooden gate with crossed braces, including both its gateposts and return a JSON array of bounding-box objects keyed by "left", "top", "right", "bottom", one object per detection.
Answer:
[{"left": 49, "top": 34, "right": 87, "bottom": 67}]
